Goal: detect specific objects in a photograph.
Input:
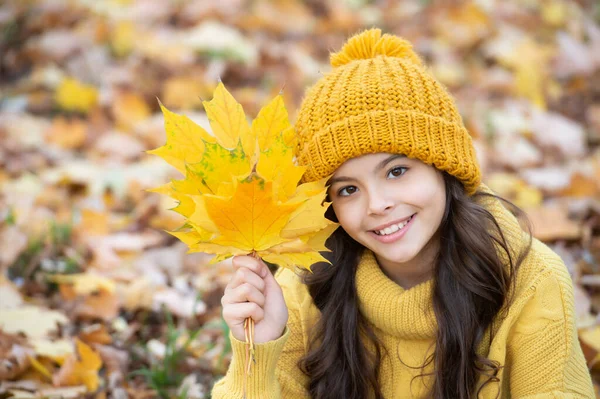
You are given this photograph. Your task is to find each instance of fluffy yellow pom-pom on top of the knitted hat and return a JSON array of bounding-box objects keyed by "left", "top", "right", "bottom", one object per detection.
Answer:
[{"left": 329, "top": 29, "right": 422, "bottom": 68}]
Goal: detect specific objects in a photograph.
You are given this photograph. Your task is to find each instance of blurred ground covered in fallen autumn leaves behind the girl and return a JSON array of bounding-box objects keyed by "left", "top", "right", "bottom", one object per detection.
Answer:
[{"left": 0, "top": 0, "right": 600, "bottom": 398}]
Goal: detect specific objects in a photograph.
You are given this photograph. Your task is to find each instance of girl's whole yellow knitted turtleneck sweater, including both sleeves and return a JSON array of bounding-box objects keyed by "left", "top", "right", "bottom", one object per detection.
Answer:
[{"left": 212, "top": 190, "right": 594, "bottom": 399}]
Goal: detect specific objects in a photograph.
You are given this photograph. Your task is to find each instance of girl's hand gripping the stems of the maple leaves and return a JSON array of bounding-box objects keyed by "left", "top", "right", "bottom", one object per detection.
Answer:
[{"left": 221, "top": 256, "right": 288, "bottom": 344}]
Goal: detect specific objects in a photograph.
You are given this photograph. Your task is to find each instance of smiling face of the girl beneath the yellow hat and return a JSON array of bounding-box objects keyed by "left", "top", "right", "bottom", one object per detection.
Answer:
[{"left": 329, "top": 153, "right": 446, "bottom": 269}]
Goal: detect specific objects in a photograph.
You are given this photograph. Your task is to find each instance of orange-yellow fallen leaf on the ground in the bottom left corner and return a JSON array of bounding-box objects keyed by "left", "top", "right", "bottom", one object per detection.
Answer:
[{"left": 53, "top": 339, "right": 102, "bottom": 392}]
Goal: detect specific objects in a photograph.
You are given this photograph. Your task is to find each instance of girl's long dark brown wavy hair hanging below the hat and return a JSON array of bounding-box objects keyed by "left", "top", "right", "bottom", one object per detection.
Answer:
[{"left": 299, "top": 172, "right": 531, "bottom": 399}]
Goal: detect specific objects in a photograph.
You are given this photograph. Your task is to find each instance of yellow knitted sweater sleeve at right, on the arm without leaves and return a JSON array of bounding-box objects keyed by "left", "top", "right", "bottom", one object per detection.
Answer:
[{"left": 505, "top": 259, "right": 595, "bottom": 399}]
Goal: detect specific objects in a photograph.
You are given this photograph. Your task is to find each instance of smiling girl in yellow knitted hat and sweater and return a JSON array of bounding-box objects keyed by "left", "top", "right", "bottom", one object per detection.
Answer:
[{"left": 212, "top": 29, "right": 594, "bottom": 399}]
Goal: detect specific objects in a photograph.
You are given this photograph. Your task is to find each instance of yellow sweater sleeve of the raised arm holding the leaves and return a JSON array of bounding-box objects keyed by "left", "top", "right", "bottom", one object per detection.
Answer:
[{"left": 211, "top": 268, "right": 310, "bottom": 399}]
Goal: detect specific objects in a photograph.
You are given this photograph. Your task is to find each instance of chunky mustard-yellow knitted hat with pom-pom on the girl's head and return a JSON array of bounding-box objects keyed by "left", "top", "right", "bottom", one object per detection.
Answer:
[{"left": 295, "top": 29, "right": 481, "bottom": 195}]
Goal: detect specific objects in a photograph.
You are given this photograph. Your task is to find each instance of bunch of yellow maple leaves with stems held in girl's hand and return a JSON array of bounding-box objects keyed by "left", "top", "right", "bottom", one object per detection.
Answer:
[{"left": 148, "top": 82, "right": 338, "bottom": 394}]
